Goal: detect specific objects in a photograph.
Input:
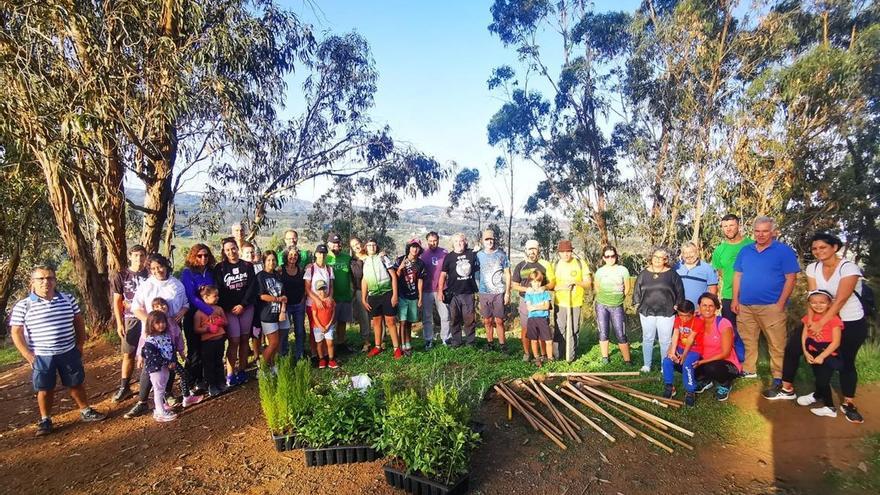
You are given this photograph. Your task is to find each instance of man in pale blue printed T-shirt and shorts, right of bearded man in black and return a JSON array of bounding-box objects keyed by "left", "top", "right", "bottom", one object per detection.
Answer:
[{"left": 477, "top": 229, "right": 510, "bottom": 353}]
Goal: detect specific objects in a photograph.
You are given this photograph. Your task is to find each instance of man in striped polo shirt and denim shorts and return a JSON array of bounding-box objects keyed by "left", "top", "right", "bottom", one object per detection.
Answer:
[{"left": 9, "top": 266, "right": 104, "bottom": 436}]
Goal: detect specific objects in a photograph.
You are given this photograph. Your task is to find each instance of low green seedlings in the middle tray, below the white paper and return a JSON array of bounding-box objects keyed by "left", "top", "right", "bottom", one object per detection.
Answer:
[{"left": 297, "top": 385, "right": 384, "bottom": 448}]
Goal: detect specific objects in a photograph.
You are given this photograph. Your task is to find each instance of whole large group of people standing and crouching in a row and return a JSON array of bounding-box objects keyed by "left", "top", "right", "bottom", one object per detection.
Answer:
[{"left": 10, "top": 215, "right": 867, "bottom": 434}]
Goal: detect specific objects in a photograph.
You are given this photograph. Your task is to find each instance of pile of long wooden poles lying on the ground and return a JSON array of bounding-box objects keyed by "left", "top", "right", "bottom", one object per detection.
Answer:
[{"left": 494, "top": 372, "right": 694, "bottom": 452}]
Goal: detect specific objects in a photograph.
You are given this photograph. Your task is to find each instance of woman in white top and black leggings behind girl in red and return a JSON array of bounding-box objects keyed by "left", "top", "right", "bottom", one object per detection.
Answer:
[{"left": 764, "top": 232, "right": 869, "bottom": 423}]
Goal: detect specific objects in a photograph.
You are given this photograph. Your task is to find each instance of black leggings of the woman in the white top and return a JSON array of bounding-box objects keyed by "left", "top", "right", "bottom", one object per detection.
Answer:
[{"left": 782, "top": 317, "right": 868, "bottom": 398}]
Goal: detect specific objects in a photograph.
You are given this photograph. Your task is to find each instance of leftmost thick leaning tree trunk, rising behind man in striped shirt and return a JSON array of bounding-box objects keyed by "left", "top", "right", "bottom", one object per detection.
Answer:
[{"left": 32, "top": 152, "right": 111, "bottom": 335}]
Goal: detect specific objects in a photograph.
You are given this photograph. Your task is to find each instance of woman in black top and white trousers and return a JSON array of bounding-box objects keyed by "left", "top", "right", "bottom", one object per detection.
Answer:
[{"left": 633, "top": 248, "right": 684, "bottom": 373}]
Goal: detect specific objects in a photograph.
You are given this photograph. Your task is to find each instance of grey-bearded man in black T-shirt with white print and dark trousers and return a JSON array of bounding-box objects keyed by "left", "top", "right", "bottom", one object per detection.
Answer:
[{"left": 438, "top": 232, "right": 480, "bottom": 347}]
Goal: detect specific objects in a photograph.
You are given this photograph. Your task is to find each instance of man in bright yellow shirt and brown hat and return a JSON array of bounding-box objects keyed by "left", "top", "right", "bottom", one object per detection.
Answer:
[{"left": 553, "top": 240, "right": 592, "bottom": 362}]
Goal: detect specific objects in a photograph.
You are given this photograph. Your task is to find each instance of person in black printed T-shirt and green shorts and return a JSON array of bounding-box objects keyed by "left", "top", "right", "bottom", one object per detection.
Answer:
[{"left": 393, "top": 239, "right": 427, "bottom": 356}]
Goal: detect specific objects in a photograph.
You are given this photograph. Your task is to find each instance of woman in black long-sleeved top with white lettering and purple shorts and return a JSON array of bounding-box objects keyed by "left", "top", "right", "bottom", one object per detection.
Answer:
[{"left": 214, "top": 237, "right": 257, "bottom": 386}]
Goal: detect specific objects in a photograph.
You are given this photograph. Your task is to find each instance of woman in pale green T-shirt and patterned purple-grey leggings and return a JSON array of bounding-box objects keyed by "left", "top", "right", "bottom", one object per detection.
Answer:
[{"left": 593, "top": 246, "right": 632, "bottom": 365}]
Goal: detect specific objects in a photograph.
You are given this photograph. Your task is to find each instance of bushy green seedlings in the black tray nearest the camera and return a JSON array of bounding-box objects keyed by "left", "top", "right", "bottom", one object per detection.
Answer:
[{"left": 375, "top": 383, "right": 480, "bottom": 483}]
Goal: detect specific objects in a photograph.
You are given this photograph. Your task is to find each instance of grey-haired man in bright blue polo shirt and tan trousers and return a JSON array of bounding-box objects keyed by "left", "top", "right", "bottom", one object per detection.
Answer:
[{"left": 731, "top": 217, "right": 801, "bottom": 382}]
